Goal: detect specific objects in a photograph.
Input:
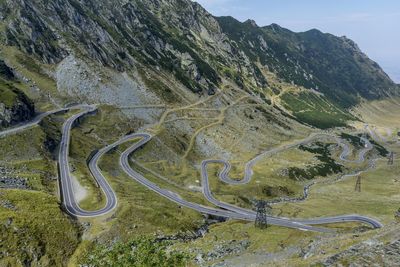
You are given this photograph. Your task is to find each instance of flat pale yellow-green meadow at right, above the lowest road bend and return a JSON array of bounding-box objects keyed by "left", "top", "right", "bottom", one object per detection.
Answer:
[{"left": 279, "top": 161, "right": 399, "bottom": 223}]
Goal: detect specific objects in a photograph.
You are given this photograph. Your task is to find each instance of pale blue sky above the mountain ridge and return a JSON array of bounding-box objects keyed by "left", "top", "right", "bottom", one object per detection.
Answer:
[{"left": 196, "top": 0, "right": 400, "bottom": 83}]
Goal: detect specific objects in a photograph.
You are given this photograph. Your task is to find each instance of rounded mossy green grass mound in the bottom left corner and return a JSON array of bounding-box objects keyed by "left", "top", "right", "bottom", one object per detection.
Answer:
[{"left": 0, "top": 190, "right": 79, "bottom": 266}]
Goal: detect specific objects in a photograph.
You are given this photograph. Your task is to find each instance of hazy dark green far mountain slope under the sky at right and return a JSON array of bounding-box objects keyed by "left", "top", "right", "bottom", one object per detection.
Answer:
[{"left": 217, "top": 17, "right": 398, "bottom": 107}]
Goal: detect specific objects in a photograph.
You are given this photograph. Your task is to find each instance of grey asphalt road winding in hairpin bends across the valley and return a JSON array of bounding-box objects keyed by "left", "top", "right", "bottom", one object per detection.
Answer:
[{"left": 0, "top": 105, "right": 382, "bottom": 232}]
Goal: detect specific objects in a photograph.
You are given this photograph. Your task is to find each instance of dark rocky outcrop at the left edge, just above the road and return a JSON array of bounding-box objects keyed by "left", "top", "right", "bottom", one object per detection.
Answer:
[{"left": 0, "top": 60, "right": 35, "bottom": 128}]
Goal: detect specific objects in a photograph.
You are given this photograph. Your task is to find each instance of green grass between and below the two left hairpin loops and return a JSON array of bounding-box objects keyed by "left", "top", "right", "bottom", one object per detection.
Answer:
[{"left": 63, "top": 106, "right": 205, "bottom": 238}]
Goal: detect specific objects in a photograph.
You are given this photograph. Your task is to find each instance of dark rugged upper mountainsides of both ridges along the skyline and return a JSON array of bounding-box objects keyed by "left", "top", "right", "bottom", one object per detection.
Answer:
[{"left": 0, "top": 0, "right": 398, "bottom": 110}]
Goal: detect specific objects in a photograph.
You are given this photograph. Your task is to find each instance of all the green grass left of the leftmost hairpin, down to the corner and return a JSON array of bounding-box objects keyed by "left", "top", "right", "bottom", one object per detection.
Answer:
[{"left": 0, "top": 111, "right": 80, "bottom": 266}]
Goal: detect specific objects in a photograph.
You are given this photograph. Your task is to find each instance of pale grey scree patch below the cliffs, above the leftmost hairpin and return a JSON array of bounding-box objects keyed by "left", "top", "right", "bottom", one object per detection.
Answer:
[{"left": 56, "top": 55, "right": 162, "bottom": 122}]
